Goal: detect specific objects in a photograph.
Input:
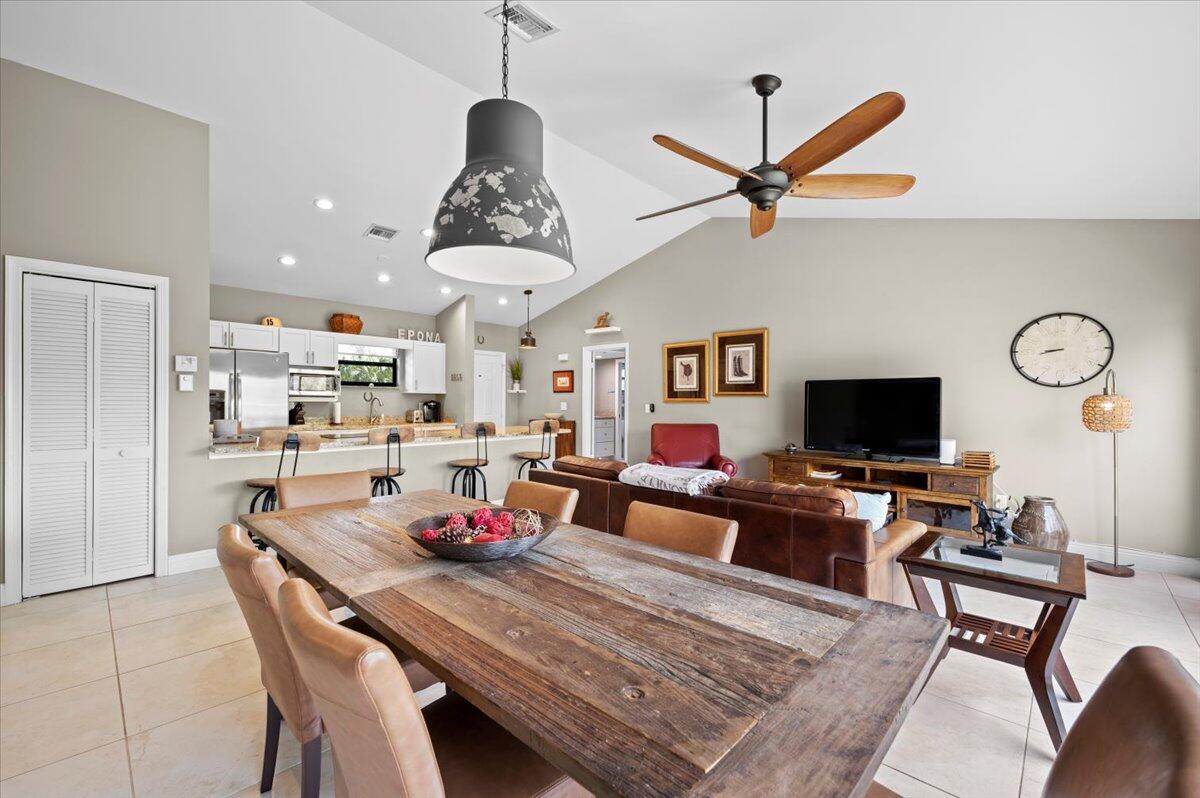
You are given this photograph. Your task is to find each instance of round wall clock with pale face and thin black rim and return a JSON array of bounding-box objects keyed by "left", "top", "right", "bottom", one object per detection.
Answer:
[{"left": 1012, "top": 313, "right": 1112, "bottom": 388}]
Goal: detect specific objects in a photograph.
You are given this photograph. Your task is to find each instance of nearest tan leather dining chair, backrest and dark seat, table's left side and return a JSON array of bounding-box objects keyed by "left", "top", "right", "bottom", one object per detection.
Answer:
[{"left": 280, "top": 580, "right": 589, "bottom": 798}]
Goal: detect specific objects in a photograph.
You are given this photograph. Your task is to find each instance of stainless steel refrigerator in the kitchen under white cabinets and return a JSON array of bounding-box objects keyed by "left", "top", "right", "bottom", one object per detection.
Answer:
[{"left": 209, "top": 349, "right": 288, "bottom": 430}]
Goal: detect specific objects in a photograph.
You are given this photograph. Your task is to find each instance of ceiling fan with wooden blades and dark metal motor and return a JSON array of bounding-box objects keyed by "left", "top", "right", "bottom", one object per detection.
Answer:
[{"left": 636, "top": 74, "right": 917, "bottom": 239}]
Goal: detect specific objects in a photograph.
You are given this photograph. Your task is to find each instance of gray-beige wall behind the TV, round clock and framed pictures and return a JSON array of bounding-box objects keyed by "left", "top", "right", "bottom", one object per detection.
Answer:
[{"left": 524, "top": 218, "right": 1200, "bottom": 556}]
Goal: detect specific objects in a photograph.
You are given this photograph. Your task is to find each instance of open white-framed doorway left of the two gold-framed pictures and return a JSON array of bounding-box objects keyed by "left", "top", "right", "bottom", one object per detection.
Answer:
[{"left": 581, "top": 343, "right": 629, "bottom": 461}]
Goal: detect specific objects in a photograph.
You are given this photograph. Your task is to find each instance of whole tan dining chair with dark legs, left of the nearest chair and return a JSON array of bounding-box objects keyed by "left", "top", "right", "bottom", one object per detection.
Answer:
[{"left": 217, "top": 523, "right": 438, "bottom": 798}]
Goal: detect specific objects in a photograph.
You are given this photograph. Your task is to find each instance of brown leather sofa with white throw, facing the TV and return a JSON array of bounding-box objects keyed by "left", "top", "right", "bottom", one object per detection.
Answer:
[{"left": 529, "top": 456, "right": 925, "bottom": 607}]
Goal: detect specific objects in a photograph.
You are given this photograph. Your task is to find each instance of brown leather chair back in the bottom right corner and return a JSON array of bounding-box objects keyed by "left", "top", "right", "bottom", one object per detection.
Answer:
[{"left": 1042, "top": 646, "right": 1200, "bottom": 798}]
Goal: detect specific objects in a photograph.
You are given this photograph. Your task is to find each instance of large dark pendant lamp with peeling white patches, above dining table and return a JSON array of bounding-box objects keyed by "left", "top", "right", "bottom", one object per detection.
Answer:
[{"left": 425, "top": 0, "right": 575, "bottom": 286}]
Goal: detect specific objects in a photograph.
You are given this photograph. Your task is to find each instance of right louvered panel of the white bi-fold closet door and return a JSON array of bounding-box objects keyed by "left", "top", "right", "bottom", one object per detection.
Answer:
[{"left": 91, "top": 283, "right": 155, "bottom": 584}]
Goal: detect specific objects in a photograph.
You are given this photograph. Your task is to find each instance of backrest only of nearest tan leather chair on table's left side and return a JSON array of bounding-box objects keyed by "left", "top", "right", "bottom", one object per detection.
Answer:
[{"left": 280, "top": 580, "right": 446, "bottom": 798}]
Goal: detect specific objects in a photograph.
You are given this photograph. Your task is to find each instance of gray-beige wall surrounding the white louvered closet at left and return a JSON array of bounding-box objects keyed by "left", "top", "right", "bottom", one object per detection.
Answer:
[{"left": 0, "top": 60, "right": 212, "bottom": 573}]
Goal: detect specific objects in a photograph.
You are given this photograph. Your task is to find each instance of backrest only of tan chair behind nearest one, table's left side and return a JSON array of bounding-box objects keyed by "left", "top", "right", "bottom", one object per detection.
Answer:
[{"left": 217, "top": 523, "right": 320, "bottom": 743}]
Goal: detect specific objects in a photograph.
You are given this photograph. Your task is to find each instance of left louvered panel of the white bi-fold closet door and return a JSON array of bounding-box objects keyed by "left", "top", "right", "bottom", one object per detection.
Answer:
[{"left": 22, "top": 275, "right": 94, "bottom": 595}]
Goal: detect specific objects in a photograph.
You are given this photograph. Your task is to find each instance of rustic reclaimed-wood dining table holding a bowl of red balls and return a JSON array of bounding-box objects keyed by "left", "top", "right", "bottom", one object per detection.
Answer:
[{"left": 241, "top": 491, "right": 948, "bottom": 798}]
